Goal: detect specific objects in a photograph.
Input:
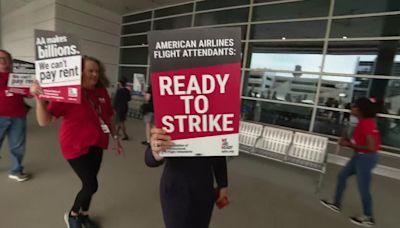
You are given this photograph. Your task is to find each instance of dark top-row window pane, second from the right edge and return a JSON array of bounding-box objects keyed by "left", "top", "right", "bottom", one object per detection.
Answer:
[{"left": 253, "top": 0, "right": 330, "bottom": 21}]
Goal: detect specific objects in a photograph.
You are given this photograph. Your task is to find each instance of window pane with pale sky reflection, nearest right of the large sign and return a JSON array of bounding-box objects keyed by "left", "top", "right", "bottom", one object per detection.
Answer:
[{"left": 248, "top": 42, "right": 323, "bottom": 72}]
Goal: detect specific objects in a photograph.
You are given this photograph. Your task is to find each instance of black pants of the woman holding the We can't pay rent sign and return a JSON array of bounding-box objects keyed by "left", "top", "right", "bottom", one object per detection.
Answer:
[{"left": 68, "top": 146, "right": 103, "bottom": 213}]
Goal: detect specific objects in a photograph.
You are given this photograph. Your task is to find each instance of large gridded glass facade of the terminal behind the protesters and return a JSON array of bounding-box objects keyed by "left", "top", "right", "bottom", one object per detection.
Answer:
[{"left": 119, "top": 0, "right": 400, "bottom": 153}]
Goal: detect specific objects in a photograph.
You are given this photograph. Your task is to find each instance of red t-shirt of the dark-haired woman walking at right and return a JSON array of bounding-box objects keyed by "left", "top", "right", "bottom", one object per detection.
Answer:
[{"left": 353, "top": 118, "right": 381, "bottom": 153}]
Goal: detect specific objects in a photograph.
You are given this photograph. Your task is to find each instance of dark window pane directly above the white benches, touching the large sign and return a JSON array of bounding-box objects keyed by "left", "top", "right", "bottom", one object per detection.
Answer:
[{"left": 241, "top": 99, "right": 312, "bottom": 131}]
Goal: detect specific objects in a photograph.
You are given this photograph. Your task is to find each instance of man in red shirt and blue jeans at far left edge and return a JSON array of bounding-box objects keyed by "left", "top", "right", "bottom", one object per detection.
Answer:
[{"left": 0, "top": 49, "right": 29, "bottom": 181}]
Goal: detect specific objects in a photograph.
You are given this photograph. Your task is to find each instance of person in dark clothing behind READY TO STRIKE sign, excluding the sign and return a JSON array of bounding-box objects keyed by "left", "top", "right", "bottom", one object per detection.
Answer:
[{"left": 145, "top": 128, "right": 229, "bottom": 228}]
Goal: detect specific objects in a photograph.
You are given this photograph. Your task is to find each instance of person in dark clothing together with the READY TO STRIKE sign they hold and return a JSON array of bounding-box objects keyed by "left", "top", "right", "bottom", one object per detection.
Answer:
[{"left": 145, "top": 28, "right": 241, "bottom": 228}]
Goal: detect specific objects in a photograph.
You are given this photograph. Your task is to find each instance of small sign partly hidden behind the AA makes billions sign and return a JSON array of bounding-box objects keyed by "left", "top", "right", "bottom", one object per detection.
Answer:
[{"left": 7, "top": 59, "right": 35, "bottom": 95}]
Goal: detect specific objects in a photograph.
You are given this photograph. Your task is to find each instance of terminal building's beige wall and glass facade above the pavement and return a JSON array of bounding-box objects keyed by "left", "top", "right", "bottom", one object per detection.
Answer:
[{"left": 1, "top": 0, "right": 400, "bottom": 180}]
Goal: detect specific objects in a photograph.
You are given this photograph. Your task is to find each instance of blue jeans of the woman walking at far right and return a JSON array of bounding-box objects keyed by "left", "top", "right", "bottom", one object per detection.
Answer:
[{"left": 334, "top": 153, "right": 379, "bottom": 217}]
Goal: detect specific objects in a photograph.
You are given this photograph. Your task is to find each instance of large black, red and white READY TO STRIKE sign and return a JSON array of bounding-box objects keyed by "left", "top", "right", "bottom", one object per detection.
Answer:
[{"left": 148, "top": 28, "right": 241, "bottom": 156}]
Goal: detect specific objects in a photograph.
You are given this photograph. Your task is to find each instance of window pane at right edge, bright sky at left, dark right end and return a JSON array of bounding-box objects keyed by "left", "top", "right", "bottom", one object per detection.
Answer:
[{"left": 324, "top": 40, "right": 400, "bottom": 75}]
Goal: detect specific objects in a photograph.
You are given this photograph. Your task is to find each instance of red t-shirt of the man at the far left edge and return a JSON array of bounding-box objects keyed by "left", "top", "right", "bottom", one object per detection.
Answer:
[{"left": 0, "top": 73, "right": 28, "bottom": 117}]
